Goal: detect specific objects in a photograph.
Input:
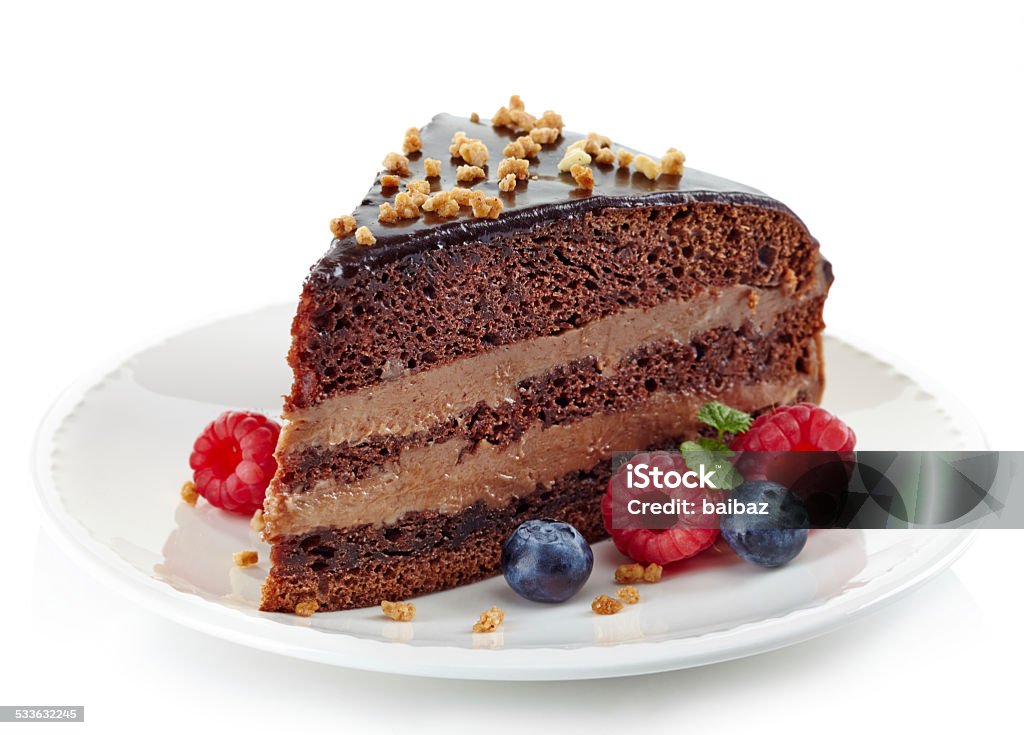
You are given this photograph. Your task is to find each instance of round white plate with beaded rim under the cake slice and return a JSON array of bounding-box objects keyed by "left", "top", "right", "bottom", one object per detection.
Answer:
[{"left": 35, "top": 305, "right": 985, "bottom": 680}]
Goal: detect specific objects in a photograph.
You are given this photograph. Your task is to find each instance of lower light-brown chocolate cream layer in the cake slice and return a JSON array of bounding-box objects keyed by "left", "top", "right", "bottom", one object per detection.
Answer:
[{"left": 265, "top": 370, "right": 821, "bottom": 538}]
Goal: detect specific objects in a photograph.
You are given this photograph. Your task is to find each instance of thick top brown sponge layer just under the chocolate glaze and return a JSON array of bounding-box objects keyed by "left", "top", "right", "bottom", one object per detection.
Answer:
[{"left": 286, "top": 202, "right": 830, "bottom": 409}]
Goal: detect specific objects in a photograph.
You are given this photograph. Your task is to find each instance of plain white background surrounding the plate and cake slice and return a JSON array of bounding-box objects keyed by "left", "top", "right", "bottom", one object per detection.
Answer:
[{"left": 0, "top": 2, "right": 1024, "bottom": 733}]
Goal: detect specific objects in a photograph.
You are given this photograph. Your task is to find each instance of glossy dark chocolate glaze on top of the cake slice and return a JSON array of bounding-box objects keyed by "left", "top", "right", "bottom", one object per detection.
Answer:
[{"left": 309, "top": 114, "right": 799, "bottom": 286}]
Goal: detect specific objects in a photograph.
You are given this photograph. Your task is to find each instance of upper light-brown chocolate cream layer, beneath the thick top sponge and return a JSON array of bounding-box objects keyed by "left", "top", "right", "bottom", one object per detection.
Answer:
[{"left": 278, "top": 276, "right": 824, "bottom": 453}]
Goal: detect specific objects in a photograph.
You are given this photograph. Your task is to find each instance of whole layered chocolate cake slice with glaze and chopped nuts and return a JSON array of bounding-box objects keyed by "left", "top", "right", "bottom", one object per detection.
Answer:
[{"left": 263, "top": 98, "right": 831, "bottom": 611}]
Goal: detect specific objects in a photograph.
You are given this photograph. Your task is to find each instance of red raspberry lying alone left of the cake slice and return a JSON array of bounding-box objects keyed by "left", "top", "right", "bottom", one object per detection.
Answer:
[{"left": 188, "top": 410, "right": 281, "bottom": 515}]
